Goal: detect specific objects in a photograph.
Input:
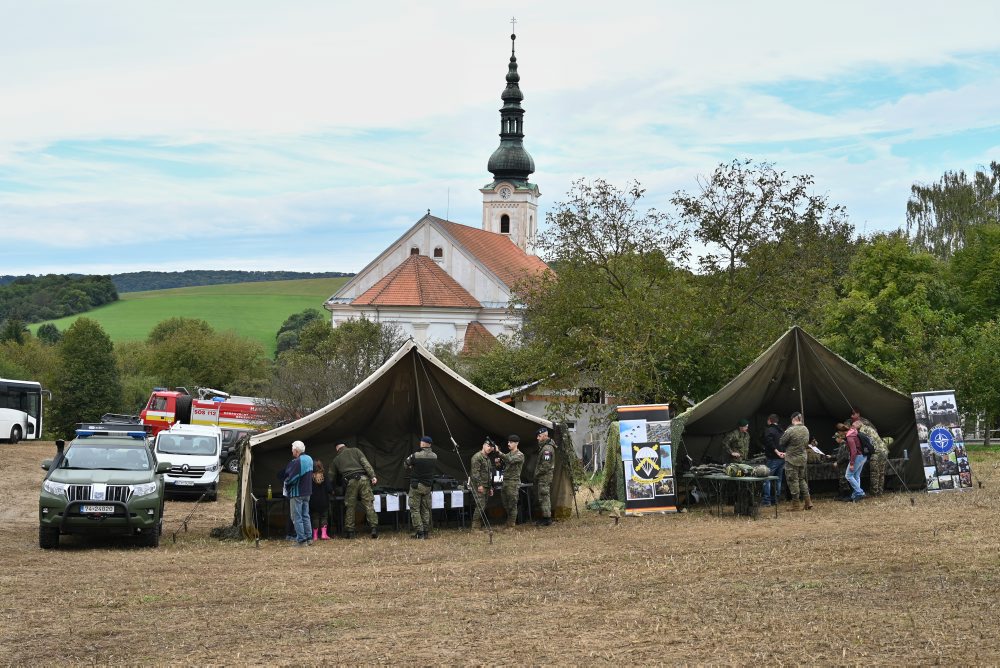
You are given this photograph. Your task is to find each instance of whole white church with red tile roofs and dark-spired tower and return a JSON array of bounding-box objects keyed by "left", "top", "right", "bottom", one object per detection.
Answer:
[{"left": 325, "top": 35, "right": 550, "bottom": 352}]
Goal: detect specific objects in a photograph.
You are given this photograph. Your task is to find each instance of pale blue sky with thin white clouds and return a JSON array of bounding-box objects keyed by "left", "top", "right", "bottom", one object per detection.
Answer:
[{"left": 0, "top": 0, "right": 1000, "bottom": 275}]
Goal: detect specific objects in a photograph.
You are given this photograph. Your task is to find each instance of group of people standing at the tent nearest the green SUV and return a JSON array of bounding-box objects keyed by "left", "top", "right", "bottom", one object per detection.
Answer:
[{"left": 278, "top": 427, "right": 556, "bottom": 547}]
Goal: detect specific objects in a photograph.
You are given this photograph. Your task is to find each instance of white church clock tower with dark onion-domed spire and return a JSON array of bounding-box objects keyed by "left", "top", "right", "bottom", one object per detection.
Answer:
[{"left": 480, "top": 30, "right": 541, "bottom": 255}]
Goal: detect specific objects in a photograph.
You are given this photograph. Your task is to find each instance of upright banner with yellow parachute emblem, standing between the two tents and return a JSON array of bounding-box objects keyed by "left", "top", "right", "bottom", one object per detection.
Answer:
[{"left": 618, "top": 418, "right": 677, "bottom": 515}]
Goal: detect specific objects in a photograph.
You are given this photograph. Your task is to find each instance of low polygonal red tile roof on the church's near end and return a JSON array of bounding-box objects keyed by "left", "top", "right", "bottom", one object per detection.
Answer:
[{"left": 351, "top": 255, "right": 482, "bottom": 308}]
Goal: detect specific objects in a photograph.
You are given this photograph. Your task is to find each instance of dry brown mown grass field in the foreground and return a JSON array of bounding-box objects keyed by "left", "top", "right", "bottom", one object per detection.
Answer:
[{"left": 0, "top": 443, "right": 1000, "bottom": 665}]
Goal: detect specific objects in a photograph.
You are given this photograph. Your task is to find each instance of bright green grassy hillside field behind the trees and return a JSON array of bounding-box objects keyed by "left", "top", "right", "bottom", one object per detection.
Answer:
[{"left": 31, "top": 277, "right": 349, "bottom": 354}]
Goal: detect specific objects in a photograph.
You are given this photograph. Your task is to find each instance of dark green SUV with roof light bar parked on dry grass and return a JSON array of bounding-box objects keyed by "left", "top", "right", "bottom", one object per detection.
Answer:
[{"left": 38, "top": 425, "right": 170, "bottom": 550}]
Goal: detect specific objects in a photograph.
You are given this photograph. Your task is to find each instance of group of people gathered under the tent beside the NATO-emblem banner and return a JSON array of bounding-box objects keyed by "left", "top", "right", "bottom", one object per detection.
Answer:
[{"left": 723, "top": 409, "right": 889, "bottom": 511}]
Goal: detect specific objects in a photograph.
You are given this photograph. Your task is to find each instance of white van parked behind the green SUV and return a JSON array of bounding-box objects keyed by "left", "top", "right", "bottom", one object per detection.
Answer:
[{"left": 153, "top": 424, "right": 222, "bottom": 501}]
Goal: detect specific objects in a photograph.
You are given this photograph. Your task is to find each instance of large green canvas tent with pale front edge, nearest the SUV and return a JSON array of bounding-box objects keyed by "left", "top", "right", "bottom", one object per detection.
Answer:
[{"left": 241, "top": 340, "right": 573, "bottom": 529}]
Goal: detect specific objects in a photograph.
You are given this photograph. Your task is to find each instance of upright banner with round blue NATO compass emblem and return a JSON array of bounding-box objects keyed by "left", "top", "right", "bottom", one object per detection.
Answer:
[{"left": 910, "top": 390, "right": 972, "bottom": 492}]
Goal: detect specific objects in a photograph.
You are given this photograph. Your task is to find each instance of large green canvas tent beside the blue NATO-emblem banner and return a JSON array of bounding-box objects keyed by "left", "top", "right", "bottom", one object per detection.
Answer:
[{"left": 671, "top": 326, "right": 924, "bottom": 489}]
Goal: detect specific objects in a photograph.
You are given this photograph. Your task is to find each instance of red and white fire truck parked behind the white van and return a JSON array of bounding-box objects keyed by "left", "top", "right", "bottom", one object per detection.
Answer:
[{"left": 139, "top": 387, "right": 266, "bottom": 435}]
